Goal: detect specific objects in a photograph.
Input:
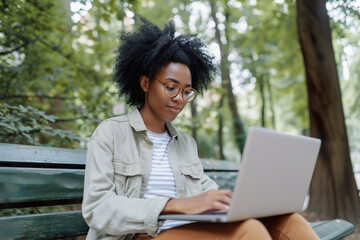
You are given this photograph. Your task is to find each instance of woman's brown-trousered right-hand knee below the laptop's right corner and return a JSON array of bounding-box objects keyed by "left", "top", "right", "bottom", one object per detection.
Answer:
[{"left": 260, "top": 213, "right": 319, "bottom": 240}]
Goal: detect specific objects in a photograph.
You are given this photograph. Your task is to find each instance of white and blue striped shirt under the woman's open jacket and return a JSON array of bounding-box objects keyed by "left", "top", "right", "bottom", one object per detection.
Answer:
[{"left": 144, "top": 131, "right": 190, "bottom": 232}]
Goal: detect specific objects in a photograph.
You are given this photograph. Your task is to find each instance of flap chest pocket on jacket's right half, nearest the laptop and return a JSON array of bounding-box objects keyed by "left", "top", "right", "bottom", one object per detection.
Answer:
[{"left": 180, "top": 164, "right": 203, "bottom": 197}]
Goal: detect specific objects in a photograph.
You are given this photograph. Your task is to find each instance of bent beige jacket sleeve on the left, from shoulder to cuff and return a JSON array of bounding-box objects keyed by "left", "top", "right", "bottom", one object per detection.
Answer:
[{"left": 82, "top": 122, "right": 169, "bottom": 236}]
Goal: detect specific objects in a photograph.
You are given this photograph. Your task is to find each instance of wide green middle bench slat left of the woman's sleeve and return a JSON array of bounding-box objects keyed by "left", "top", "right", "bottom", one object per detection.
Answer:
[{"left": 0, "top": 167, "right": 84, "bottom": 208}]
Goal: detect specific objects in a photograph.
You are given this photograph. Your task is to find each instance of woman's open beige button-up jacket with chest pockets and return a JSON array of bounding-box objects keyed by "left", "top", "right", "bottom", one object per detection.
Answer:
[{"left": 82, "top": 110, "right": 217, "bottom": 239}]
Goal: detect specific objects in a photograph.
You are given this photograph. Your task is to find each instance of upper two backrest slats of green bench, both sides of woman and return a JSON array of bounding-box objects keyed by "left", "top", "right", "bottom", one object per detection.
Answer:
[{"left": 0, "top": 143, "right": 239, "bottom": 209}]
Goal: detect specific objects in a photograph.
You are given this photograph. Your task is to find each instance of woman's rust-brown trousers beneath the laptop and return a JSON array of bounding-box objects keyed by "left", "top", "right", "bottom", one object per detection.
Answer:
[{"left": 133, "top": 213, "right": 319, "bottom": 240}]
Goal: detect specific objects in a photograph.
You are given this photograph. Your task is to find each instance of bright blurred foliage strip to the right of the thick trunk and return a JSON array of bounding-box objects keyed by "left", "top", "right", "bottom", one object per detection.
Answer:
[{"left": 328, "top": 0, "right": 360, "bottom": 162}]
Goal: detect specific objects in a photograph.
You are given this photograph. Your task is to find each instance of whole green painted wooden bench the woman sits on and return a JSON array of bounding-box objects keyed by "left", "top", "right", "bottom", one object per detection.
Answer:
[{"left": 0, "top": 143, "right": 354, "bottom": 240}]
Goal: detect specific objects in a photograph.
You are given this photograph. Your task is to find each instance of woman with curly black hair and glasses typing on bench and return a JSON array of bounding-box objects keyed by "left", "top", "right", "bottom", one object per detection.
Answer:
[{"left": 82, "top": 18, "right": 318, "bottom": 240}]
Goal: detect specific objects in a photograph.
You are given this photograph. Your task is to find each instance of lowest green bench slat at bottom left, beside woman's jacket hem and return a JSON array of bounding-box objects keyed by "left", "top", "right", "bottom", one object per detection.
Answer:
[{"left": 0, "top": 211, "right": 89, "bottom": 240}]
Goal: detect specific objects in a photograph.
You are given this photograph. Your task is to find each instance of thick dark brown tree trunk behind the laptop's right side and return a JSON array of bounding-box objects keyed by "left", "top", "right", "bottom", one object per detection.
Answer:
[{"left": 297, "top": 0, "right": 360, "bottom": 223}]
